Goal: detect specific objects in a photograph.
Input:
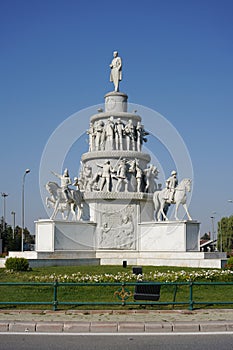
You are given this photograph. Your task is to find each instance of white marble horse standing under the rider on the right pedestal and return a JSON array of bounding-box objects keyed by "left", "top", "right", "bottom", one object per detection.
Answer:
[{"left": 153, "top": 179, "right": 192, "bottom": 221}]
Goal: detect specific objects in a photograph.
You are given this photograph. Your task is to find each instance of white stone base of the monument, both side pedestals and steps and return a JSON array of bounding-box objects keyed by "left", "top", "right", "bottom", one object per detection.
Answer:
[{"left": 9, "top": 220, "right": 227, "bottom": 268}]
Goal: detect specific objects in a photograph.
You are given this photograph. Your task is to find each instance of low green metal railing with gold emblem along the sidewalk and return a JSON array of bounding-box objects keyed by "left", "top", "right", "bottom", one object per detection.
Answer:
[{"left": 0, "top": 281, "right": 233, "bottom": 311}]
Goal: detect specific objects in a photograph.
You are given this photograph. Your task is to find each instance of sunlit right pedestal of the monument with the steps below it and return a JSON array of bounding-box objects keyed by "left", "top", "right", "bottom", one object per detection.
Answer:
[{"left": 96, "top": 221, "right": 227, "bottom": 268}]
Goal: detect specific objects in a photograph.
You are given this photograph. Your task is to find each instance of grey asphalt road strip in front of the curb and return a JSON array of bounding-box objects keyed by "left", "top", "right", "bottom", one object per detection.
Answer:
[{"left": 0, "top": 334, "right": 233, "bottom": 350}]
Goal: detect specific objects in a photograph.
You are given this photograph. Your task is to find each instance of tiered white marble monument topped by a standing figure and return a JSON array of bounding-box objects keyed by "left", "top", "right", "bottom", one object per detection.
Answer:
[{"left": 19, "top": 51, "right": 224, "bottom": 268}]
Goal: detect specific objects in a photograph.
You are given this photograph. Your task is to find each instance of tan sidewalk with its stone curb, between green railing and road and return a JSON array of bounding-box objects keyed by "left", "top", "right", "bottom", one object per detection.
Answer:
[{"left": 0, "top": 309, "right": 233, "bottom": 333}]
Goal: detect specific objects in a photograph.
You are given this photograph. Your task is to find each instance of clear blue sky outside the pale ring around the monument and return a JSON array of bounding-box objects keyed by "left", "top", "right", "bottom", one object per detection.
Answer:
[{"left": 0, "top": 0, "right": 233, "bottom": 232}]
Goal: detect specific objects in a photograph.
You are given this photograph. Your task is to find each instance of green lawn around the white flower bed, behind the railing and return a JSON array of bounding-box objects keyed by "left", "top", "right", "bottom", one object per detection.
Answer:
[{"left": 0, "top": 266, "right": 233, "bottom": 309}]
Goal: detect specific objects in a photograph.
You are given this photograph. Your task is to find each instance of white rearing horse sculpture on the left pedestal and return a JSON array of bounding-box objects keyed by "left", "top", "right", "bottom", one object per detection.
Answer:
[{"left": 46, "top": 181, "right": 83, "bottom": 220}]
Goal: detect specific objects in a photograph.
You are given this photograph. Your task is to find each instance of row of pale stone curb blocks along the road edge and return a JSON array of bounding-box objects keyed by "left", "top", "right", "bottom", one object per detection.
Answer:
[{"left": 0, "top": 321, "right": 233, "bottom": 334}]
